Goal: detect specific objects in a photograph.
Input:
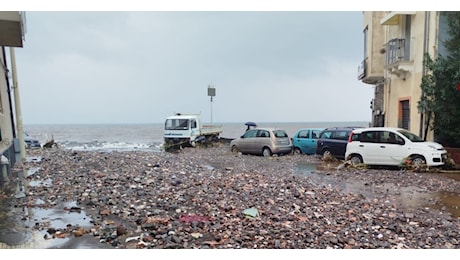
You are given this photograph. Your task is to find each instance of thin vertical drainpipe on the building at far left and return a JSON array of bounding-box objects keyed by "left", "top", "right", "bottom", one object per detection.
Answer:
[{"left": 10, "top": 47, "right": 26, "bottom": 162}]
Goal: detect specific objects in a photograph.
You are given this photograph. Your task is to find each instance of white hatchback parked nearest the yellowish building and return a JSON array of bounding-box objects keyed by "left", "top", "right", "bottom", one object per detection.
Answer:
[{"left": 345, "top": 127, "right": 447, "bottom": 167}]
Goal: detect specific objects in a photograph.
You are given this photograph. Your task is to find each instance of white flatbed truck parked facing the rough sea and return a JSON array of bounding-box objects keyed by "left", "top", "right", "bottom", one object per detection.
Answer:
[{"left": 163, "top": 113, "right": 222, "bottom": 150}]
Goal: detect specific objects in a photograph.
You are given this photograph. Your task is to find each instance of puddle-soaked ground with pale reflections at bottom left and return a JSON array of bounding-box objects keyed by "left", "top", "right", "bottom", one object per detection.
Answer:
[{"left": 0, "top": 168, "right": 112, "bottom": 249}]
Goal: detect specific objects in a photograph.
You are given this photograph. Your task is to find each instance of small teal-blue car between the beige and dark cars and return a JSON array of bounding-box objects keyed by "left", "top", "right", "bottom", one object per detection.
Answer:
[{"left": 292, "top": 128, "right": 324, "bottom": 155}]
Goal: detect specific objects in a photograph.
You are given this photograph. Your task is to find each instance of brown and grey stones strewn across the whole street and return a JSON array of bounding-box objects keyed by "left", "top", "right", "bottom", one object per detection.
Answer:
[{"left": 6, "top": 144, "right": 460, "bottom": 249}]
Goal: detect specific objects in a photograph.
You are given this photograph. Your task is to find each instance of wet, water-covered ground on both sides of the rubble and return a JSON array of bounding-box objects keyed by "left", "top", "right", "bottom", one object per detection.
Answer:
[{"left": 0, "top": 151, "right": 460, "bottom": 249}]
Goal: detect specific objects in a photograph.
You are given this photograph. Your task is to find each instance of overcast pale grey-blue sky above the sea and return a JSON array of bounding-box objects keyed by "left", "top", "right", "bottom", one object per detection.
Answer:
[{"left": 7, "top": 1, "right": 446, "bottom": 124}]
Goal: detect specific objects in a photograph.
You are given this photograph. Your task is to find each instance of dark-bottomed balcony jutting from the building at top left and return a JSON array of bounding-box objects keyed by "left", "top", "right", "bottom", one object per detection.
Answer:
[{"left": 0, "top": 11, "right": 25, "bottom": 47}]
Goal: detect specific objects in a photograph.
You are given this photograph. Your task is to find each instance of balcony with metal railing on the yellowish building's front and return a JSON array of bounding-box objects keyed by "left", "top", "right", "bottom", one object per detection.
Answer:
[{"left": 385, "top": 39, "right": 413, "bottom": 79}]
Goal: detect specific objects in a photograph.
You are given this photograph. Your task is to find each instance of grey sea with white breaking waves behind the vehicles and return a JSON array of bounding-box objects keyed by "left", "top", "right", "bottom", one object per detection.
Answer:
[{"left": 23, "top": 121, "right": 369, "bottom": 152}]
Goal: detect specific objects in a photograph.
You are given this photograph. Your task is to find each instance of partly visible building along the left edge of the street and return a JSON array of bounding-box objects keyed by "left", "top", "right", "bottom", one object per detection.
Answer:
[{"left": 0, "top": 11, "right": 25, "bottom": 190}]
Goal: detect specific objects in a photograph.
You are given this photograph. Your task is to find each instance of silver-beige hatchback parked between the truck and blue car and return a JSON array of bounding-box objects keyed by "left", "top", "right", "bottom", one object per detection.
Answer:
[{"left": 230, "top": 127, "right": 292, "bottom": 156}]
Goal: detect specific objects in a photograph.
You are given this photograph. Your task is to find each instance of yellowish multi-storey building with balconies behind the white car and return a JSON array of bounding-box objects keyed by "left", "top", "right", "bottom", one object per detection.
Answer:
[{"left": 358, "top": 11, "right": 447, "bottom": 140}]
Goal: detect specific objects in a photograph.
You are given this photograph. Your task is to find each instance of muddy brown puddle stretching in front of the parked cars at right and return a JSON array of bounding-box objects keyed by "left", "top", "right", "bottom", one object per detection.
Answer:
[{"left": 294, "top": 162, "right": 460, "bottom": 218}]
